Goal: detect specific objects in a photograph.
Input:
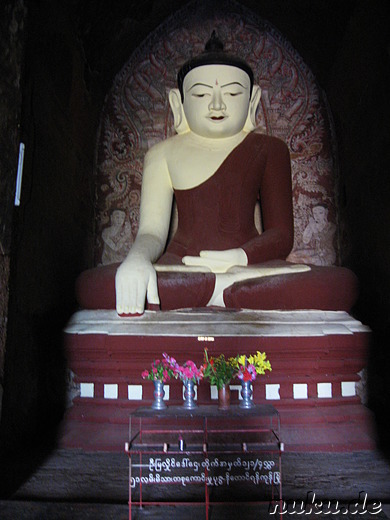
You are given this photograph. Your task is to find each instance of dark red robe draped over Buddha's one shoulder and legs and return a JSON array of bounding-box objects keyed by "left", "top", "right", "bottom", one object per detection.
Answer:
[{"left": 76, "top": 133, "right": 358, "bottom": 311}]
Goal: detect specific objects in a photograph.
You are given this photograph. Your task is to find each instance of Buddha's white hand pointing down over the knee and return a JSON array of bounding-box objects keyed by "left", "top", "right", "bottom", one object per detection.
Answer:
[{"left": 115, "top": 258, "right": 160, "bottom": 315}]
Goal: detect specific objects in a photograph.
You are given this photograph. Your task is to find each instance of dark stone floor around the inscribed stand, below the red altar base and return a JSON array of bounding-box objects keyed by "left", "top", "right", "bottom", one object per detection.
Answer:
[{"left": 0, "top": 450, "right": 390, "bottom": 520}]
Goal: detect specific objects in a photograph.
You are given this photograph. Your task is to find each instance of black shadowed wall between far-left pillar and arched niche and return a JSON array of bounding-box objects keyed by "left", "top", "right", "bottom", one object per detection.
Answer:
[{"left": 0, "top": 1, "right": 97, "bottom": 492}]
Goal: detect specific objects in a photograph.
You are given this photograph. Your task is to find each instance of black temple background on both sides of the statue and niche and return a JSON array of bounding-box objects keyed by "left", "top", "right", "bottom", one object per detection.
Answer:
[{"left": 0, "top": 0, "right": 390, "bottom": 518}]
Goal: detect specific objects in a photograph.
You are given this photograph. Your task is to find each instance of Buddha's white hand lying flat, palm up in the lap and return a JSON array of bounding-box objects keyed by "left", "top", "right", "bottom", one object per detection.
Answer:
[{"left": 182, "top": 247, "right": 248, "bottom": 273}]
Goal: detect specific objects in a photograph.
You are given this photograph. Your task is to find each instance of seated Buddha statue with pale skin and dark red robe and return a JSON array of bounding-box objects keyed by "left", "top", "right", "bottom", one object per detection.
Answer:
[{"left": 78, "top": 33, "right": 357, "bottom": 315}]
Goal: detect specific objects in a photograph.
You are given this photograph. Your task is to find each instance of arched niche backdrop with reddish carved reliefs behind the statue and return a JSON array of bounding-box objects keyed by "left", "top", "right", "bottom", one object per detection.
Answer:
[{"left": 95, "top": 1, "right": 338, "bottom": 265}]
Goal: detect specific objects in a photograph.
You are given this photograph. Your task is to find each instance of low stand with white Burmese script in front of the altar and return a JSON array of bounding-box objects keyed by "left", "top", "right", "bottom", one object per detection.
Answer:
[{"left": 126, "top": 404, "right": 284, "bottom": 519}]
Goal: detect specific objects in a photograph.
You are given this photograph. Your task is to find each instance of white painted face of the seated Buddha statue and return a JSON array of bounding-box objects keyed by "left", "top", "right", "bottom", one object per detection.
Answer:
[{"left": 183, "top": 65, "right": 250, "bottom": 139}]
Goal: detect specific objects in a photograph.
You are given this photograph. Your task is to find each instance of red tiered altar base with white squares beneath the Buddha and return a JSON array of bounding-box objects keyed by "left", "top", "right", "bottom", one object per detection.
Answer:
[{"left": 61, "top": 310, "right": 375, "bottom": 451}]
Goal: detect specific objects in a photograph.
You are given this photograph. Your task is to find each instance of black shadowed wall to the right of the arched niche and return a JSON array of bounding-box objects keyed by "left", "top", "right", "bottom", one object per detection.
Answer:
[{"left": 327, "top": 1, "right": 390, "bottom": 451}]
